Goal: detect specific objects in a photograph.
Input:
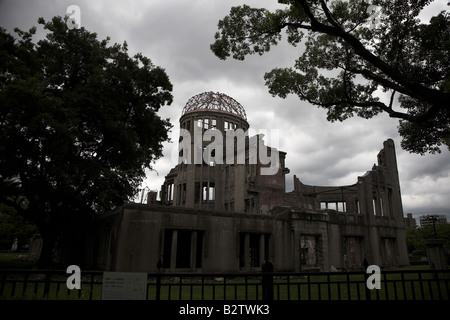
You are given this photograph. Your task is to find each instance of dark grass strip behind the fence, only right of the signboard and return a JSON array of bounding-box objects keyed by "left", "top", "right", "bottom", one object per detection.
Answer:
[{"left": 148, "top": 269, "right": 450, "bottom": 300}]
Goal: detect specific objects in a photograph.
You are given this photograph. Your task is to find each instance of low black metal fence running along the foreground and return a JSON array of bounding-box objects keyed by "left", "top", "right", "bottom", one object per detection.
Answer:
[{"left": 0, "top": 270, "right": 450, "bottom": 300}]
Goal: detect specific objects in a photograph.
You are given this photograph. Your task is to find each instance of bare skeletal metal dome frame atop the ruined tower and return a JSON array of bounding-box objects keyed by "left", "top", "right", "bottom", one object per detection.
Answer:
[{"left": 182, "top": 91, "right": 247, "bottom": 121}]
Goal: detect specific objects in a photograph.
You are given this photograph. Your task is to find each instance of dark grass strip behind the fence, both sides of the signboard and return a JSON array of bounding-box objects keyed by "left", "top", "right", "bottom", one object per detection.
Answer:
[{"left": 0, "top": 275, "right": 449, "bottom": 300}]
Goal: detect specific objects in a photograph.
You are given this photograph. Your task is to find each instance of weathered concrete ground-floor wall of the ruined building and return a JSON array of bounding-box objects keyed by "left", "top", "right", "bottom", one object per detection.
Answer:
[{"left": 90, "top": 200, "right": 407, "bottom": 272}]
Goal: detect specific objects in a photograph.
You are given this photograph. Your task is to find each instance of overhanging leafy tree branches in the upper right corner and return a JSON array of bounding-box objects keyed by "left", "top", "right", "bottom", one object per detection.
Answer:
[{"left": 211, "top": 0, "right": 450, "bottom": 154}]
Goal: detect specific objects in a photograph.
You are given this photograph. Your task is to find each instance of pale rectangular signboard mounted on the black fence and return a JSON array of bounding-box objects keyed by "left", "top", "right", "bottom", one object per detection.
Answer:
[{"left": 102, "top": 272, "right": 147, "bottom": 300}]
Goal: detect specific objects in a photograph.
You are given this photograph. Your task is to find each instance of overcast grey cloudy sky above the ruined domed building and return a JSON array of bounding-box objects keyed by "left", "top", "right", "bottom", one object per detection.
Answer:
[{"left": 0, "top": 0, "right": 450, "bottom": 221}]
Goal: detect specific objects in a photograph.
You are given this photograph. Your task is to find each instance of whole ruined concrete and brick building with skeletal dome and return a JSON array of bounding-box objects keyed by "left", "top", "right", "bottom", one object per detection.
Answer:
[{"left": 89, "top": 92, "right": 409, "bottom": 272}]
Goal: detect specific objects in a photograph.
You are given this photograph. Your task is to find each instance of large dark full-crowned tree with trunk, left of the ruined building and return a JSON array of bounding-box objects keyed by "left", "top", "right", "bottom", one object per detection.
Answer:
[{"left": 0, "top": 17, "right": 173, "bottom": 266}]
